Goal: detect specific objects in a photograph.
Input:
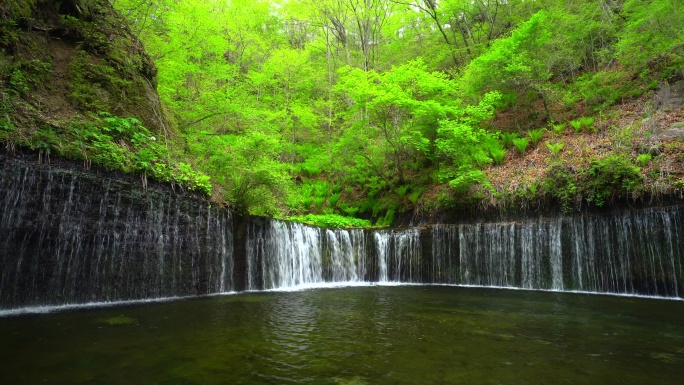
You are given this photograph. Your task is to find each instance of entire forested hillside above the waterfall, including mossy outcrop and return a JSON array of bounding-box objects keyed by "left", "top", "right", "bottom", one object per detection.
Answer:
[{"left": 0, "top": 0, "right": 684, "bottom": 226}]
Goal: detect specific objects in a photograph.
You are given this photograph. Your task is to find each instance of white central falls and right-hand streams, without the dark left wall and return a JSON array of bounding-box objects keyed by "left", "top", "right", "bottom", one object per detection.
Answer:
[{"left": 248, "top": 208, "right": 684, "bottom": 297}]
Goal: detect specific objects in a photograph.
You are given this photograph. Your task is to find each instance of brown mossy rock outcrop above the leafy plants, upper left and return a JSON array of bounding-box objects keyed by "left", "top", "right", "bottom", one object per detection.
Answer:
[{"left": 0, "top": 0, "right": 167, "bottom": 136}]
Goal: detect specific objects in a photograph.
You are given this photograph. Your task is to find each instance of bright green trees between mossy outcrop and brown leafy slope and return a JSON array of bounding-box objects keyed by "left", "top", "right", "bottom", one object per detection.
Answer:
[{"left": 87, "top": 0, "right": 684, "bottom": 216}]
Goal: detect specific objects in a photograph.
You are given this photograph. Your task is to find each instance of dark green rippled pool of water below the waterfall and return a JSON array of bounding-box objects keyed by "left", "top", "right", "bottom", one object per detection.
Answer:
[{"left": 0, "top": 286, "right": 684, "bottom": 385}]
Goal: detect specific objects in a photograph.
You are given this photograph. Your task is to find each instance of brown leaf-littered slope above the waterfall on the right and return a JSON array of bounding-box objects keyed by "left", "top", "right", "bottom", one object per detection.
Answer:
[{"left": 424, "top": 82, "right": 684, "bottom": 214}]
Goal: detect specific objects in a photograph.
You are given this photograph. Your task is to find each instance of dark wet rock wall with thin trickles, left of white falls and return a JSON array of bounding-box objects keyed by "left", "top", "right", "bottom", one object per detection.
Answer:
[{"left": 0, "top": 155, "right": 233, "bottom": 308}]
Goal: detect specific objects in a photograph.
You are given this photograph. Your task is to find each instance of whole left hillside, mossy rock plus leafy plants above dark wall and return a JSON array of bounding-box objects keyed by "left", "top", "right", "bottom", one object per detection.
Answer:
[{"left": 0, "top": 0, "right": 211, "bottom": 193}]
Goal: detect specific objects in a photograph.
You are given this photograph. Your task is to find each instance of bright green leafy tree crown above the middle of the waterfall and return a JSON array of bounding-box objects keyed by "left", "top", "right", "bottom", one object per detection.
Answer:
[{"left": 336, "top": 61, "right": 458, "bottom": 184}]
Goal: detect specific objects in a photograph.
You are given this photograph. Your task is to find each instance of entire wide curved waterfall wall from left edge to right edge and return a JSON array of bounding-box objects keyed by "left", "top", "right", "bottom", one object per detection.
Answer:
[{"left": 0, "top": 153, "right": 684, "bottom": 309}]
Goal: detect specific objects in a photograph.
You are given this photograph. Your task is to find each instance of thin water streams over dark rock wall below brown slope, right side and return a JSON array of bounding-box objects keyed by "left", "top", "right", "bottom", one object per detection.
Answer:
[{"left": 432, "top": 208, "right": 684, "bottom": 297}]
